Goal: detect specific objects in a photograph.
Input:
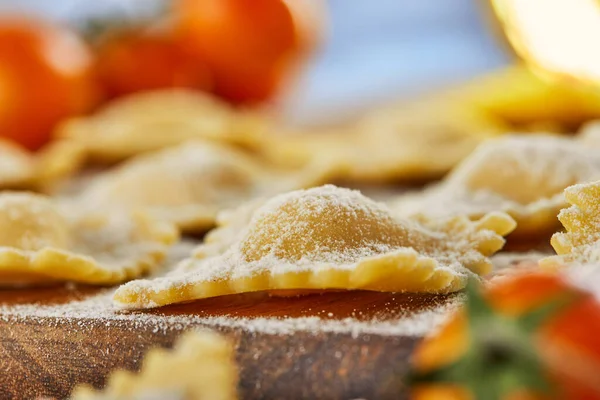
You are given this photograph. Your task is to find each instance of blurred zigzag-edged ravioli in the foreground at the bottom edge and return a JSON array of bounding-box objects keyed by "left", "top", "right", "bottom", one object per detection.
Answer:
[{"left": 71, "top": 331, "right": 238, "bottom": 400}]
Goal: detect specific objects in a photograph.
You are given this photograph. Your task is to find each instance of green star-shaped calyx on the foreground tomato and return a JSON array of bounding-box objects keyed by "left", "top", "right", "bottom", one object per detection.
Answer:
[{"left": 410, "top": 280, "right": 556, "bottom": 400}]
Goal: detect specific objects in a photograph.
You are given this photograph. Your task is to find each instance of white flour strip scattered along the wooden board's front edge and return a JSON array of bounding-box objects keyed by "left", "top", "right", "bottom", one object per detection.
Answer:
[{"left": 0, "top": 290, "right": 463, "bottom": 337}]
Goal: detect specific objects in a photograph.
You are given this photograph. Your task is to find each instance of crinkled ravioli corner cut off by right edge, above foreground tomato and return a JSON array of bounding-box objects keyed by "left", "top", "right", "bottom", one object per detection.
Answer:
[{"left": 540, "top": 181, "right": 600, "bottom": 267}]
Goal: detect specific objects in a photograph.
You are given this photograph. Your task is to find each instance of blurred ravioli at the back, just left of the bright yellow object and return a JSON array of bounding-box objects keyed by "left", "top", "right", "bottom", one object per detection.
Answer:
[{"left": 343, "top": 102, "right": 505, "bottom": 182}]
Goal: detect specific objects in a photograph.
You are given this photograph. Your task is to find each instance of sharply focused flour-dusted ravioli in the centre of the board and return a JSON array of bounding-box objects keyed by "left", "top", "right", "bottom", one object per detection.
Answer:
[{"left": 114, "top": 185, "right": 514, "bottom": 308}]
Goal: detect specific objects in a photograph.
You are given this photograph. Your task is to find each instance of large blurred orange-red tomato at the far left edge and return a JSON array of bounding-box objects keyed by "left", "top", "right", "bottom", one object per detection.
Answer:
[{"left": 0, "top": 18, "right": 96, "bottom": 150}]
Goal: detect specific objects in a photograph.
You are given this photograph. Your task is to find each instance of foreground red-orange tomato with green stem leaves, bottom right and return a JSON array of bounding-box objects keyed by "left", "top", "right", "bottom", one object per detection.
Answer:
[{"left": 412, "top": 271, "right": 600, "bottom": 400}]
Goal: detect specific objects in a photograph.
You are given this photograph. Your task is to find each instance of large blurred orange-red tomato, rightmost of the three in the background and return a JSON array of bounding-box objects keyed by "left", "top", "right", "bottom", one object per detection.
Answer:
[{"left": 174, "top": 0, "right": 322, "bottom": 103}]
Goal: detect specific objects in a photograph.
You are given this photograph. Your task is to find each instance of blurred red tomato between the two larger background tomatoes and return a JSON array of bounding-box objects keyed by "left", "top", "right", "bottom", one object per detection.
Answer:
[{"left": 96, "top": 31, "right": 212, "bottom": 97}]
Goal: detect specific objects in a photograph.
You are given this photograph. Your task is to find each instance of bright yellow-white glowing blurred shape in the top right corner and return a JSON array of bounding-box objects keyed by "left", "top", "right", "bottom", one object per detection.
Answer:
[{"left": 490, "top": 0, "right": 600, "bottom": 84}]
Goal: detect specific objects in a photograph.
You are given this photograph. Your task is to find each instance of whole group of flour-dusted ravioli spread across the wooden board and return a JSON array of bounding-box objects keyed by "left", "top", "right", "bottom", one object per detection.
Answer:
[{"left": 0, "top": 87, "right": 600, "bottom": 309}]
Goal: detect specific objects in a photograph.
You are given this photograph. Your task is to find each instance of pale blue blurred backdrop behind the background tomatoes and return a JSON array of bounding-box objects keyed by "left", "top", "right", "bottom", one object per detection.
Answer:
[{"left": 0, "top": 0, "right": 509, "bottom": 123}]
